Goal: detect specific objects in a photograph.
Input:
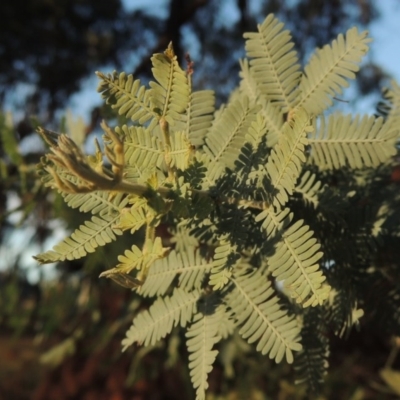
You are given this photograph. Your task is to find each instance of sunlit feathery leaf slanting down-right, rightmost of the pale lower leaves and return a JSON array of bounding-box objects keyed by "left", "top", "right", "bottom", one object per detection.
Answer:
[{"left": 269, "top": 220, "right": 330, "bottom": 307}]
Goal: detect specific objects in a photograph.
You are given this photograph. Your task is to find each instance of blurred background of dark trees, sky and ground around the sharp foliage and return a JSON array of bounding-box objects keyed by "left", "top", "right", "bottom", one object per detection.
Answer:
[{"left": 0, "top": 0, "right": 400, "bottom": 400}]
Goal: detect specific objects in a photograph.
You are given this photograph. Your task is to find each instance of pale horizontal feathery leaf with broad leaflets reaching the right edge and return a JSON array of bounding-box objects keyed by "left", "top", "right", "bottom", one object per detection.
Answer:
[{"left": 309, "top": 113, "right": 397, "bottom": 169}]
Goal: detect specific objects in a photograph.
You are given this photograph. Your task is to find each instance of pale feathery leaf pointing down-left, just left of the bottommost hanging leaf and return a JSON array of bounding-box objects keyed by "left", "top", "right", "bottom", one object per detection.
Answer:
[{"left": 122, "top": 288, "right": 200, "bottom": 351}]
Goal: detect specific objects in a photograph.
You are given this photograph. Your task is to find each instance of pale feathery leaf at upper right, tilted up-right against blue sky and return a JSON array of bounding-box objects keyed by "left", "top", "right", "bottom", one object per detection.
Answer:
[{"left": 299, "top": 28, "right": 371, "bottom": 115}]
